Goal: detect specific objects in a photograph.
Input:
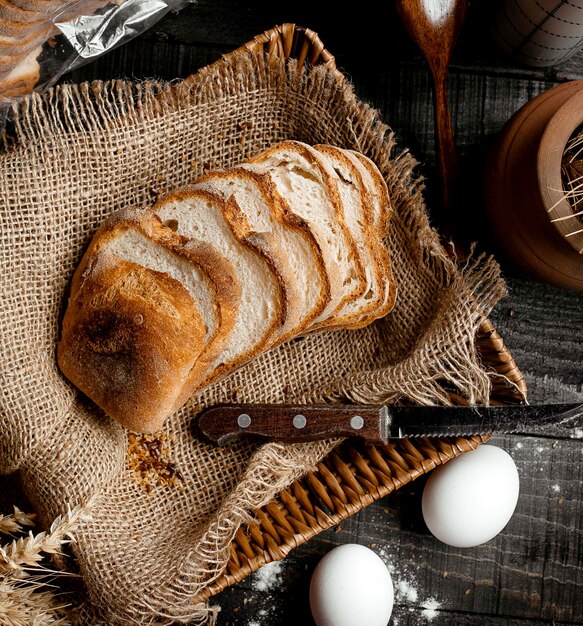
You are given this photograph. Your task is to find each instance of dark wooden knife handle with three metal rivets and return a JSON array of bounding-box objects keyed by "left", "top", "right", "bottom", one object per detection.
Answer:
[{"left": 198, "top": 404, "right": 387, "bottom": 446}]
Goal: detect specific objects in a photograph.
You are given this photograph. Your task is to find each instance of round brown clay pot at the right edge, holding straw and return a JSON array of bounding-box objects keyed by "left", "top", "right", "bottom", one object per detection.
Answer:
[{"left": 484, "top": 81, "right": 583, "bottom": 291}]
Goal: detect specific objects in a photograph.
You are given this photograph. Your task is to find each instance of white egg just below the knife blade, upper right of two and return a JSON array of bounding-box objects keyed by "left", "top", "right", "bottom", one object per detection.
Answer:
[{"left": 422, "top": 445, "right": 519, "bottom": 548}]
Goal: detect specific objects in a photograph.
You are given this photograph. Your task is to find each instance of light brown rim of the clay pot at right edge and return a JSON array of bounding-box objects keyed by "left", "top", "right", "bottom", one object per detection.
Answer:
[{"left": 537, "top": 81, "right": 583, "bottom": 252}]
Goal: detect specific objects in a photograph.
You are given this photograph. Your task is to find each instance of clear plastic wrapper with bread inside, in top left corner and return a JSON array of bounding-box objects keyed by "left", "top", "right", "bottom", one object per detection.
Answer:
[{"left": 0, "top": 0, "right": 194, "bottom": 126}]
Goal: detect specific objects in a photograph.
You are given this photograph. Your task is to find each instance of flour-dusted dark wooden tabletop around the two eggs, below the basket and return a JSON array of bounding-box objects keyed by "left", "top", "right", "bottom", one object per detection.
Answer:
[{"left": 217, "top": 436, "right": 583, "bottom": 625}]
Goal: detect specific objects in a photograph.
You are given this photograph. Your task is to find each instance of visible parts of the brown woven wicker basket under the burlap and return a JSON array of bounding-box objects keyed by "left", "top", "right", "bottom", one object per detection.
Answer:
[{"left": 200, "top": 24, "right": 526, "bottom": 600}]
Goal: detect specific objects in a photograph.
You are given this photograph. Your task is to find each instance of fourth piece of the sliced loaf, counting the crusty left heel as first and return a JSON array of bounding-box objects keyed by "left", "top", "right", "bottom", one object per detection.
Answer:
[{"left": 193, "top": 167, "right": 330, "bottom": 342}]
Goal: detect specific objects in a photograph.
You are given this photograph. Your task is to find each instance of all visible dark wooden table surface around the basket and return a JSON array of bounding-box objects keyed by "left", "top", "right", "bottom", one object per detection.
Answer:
[{"left": 67, "top": 0, "right": 583, "bottom": 626}]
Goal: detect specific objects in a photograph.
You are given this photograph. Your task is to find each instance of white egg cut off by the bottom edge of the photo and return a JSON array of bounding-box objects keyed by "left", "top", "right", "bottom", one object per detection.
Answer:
[{"left": 310, "top": 543, "right": 394, "bottom": 626}]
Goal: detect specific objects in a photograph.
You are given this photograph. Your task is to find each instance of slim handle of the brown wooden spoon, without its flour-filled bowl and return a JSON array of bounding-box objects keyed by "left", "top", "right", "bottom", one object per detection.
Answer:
[{"left": 433, "top": 72, "right": 458, "bottom": 214}]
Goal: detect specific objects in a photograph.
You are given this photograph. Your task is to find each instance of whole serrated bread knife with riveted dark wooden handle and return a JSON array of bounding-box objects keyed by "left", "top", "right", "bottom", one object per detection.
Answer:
[{"left": 198, "top": 404, "right": 583, "bottom": 446}]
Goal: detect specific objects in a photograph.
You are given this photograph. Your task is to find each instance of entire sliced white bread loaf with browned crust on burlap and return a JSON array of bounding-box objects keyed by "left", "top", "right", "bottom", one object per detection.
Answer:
[{"left": 58, "top": 142, "right": 396, "bottom": 432}]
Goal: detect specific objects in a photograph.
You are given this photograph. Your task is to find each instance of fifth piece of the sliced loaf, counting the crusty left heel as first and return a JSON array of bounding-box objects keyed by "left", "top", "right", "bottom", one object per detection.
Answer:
[{"left": 241, "top": 141, "right": 365, "bottom": 327}]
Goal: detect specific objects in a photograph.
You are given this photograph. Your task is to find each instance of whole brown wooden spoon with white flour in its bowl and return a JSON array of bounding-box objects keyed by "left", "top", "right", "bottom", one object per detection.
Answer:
[{"left": 397, "top": 0, "right": 468, "bottom": 219}]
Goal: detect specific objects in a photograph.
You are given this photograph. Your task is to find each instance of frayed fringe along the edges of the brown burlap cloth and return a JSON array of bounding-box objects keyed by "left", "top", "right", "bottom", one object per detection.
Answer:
[{"left": 3, "top": 55, "right": 520, "bottom": 623}]
